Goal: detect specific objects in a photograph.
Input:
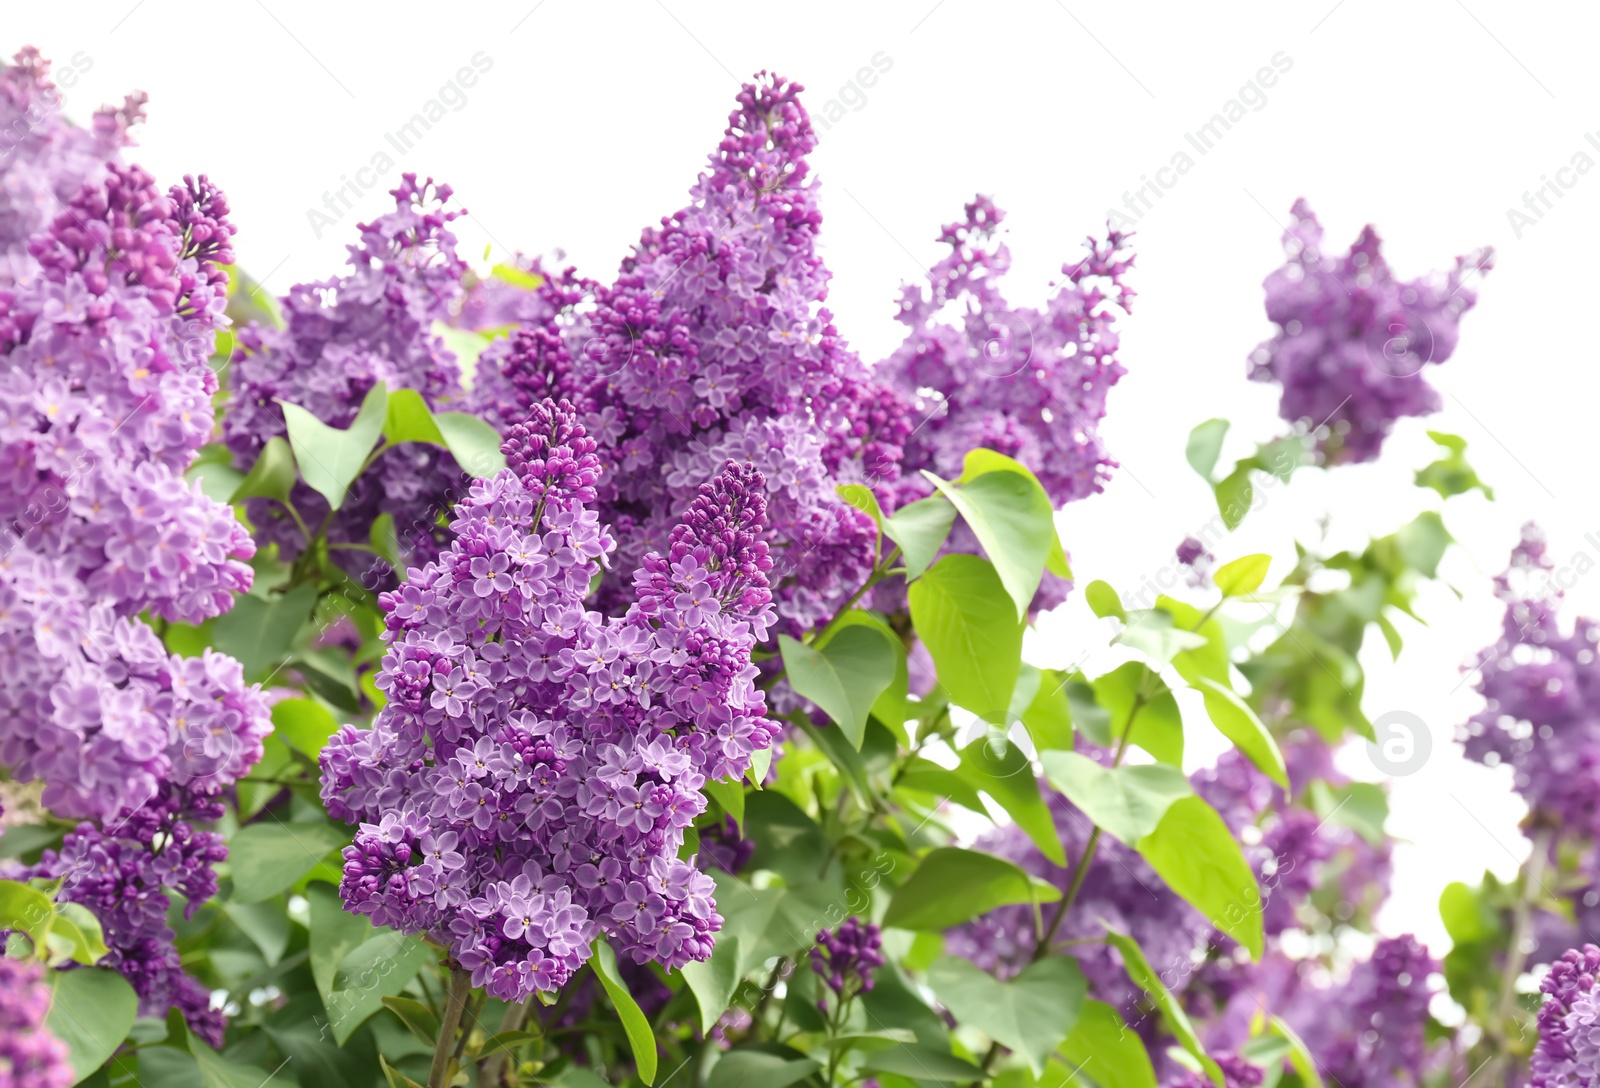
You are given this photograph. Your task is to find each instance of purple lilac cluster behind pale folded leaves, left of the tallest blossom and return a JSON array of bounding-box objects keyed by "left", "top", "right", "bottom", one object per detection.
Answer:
[{"left": 222, "top": 174, "right": 466, "bottom": 563}]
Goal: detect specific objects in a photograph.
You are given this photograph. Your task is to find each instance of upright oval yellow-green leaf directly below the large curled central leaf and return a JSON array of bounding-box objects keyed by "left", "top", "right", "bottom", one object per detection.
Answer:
[{"left": 909, "top": 555, "right": 1024, "bottom": 722}]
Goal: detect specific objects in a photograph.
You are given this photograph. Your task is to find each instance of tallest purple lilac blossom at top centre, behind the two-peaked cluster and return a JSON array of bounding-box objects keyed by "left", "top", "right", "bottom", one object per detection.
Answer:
[{"left": 552, "top": 74, "right": 910, "bottom": 634}]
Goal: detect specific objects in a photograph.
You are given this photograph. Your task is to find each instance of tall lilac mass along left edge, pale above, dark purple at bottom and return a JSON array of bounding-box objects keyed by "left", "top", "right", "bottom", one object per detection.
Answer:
[{"left": 0, "top": 66, "right": 272, "bottom": 1042}]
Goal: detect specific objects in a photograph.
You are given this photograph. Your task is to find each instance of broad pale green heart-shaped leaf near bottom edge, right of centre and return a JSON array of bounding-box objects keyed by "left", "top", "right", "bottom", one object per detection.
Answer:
[{"left": 928, "top": 955, "right": 1088, "bottom": 1075}]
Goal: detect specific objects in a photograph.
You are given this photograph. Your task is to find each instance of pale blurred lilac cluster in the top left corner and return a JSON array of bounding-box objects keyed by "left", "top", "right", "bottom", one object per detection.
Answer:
[{"left": 0, "top": 46, "right": 146, "bottom": 285}]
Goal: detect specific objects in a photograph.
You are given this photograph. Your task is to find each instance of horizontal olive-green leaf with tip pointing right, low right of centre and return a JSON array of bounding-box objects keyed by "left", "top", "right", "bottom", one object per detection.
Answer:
[{"left": 883, "top": 846, "right": 1061, "bottom": 930}]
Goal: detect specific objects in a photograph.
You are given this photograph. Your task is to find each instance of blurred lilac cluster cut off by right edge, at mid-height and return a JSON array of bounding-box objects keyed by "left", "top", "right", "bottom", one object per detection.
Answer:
[{"left": 1461, "top": 525, "right": 1600, "bottom": 838}]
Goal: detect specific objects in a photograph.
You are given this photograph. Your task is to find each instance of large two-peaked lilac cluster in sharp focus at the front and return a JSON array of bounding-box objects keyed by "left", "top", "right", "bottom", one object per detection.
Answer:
[{"left": 322, "top": 400, "right": 778, "bottom": 1000}]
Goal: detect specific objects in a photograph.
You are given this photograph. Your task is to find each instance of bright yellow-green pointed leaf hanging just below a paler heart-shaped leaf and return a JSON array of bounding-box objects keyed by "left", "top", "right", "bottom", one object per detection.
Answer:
[{"left": 1134, "top": 797, "right": 1262, "bottom": 958}]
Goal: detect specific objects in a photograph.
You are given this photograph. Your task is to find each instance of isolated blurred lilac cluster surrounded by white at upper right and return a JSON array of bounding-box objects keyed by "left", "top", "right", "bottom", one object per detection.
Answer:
[{"left": 1250, "top": 200, "right": 1493, "bottom": 464}]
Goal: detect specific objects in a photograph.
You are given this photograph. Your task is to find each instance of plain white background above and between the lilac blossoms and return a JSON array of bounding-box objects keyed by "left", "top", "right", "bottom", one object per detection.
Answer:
[{"left": 15, "top": 0, "right": 1600, "bottom": 952}]
